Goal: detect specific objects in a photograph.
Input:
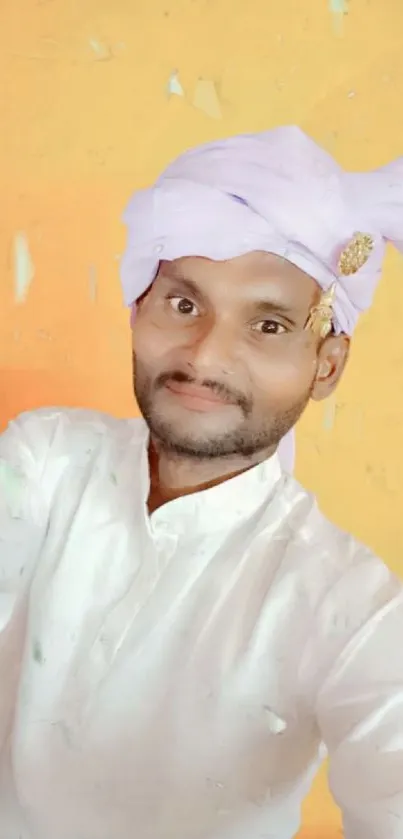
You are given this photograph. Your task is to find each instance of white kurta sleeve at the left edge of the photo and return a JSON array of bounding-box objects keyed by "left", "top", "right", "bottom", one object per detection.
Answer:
[{"left": 0, "top": 412, "right": 49, "bottom": 749}]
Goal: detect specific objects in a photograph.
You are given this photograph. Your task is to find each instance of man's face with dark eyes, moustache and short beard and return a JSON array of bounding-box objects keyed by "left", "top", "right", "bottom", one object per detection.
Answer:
[{"left": 133, "top": 252, "right": 344, "bottom": 458}]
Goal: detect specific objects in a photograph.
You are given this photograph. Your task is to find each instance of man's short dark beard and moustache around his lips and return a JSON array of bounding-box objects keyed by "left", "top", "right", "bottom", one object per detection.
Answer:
[{"left": 133, "top": 358, "right": 312, "bottom": 461}]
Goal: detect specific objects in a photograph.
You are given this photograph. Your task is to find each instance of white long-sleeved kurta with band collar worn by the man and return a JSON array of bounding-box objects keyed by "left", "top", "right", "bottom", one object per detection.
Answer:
[{"left": 0, "top": 410, "right": 403, "bottom": 839}]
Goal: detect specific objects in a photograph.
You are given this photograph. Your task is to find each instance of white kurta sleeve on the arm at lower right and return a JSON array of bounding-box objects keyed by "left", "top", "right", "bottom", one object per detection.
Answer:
[{"left": 316, "top": 557, "right": 403, "bottom": 839}]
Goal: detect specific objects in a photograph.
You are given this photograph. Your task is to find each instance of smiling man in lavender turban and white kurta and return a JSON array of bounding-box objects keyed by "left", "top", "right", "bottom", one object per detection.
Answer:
[{"left": 0, "top": 128, "right": 403, "bottom": 839}]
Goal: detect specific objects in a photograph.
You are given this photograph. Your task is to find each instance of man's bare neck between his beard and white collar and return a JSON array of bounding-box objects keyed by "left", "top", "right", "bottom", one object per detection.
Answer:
[{"left": 148, "top": 440, "right": 276, "bottom": 513}]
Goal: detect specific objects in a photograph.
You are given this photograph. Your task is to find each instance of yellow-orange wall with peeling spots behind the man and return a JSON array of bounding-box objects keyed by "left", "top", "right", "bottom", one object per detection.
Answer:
[{"left": 0, "top": 0, "right": 403, "bottom": 839}]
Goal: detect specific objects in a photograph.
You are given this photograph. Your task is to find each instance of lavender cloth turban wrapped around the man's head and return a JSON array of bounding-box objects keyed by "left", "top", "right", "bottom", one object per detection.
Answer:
[{"left": 121, "top": 126, "right": 403, "bottom": 469}]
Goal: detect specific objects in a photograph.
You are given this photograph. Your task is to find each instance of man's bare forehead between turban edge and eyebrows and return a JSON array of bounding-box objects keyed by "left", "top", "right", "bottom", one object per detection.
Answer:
[{"left": 159, "top": 251, "right": 321, "bottom": 309}]
